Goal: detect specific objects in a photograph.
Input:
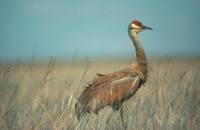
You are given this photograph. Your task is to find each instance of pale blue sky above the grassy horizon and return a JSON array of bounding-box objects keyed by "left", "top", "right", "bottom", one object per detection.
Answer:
[{"left": 0, "top": 0, "right": 200, "bottom": 60}]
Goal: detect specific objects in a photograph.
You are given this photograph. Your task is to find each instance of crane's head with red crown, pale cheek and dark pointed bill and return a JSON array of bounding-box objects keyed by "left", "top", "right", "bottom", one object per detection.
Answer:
[{"left": 128, "top": 20, "right": 153, "bottom": 33}]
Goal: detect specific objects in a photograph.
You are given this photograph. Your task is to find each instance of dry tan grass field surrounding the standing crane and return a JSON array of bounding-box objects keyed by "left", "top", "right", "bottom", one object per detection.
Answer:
[{"left": 0, "top": 58, "right": 200, "bottom": 130}]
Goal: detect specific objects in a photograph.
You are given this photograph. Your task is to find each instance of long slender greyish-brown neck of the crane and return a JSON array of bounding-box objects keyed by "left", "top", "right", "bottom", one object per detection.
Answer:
[{"left": 129, "top": 31, "right": 148, "bottom": 80}]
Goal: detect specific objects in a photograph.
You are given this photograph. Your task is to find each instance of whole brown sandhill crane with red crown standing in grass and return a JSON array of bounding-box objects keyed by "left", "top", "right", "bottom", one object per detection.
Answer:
[{"left": 75, "top": 20, "right": 152, "bottom": 128}]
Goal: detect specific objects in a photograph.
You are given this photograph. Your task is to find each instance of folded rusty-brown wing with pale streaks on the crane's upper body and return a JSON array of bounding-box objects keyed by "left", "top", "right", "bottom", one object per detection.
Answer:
[{"left": 81, "top": 68, "right": 141, "bottom": 100}]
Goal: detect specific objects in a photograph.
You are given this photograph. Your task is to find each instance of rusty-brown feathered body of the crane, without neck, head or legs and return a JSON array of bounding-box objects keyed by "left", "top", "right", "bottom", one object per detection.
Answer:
[{"left": 75, "top": 63, "right": 142, "bottom": 118}]
